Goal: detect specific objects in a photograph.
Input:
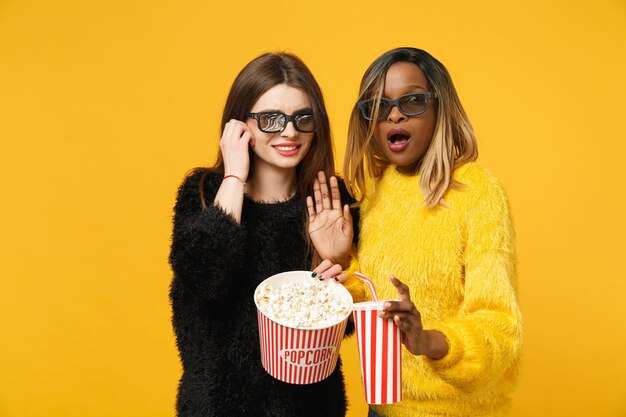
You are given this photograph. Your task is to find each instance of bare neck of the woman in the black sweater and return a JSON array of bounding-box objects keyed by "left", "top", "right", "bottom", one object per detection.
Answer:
[{"left": 246, "top": 161, "right": 296, "bottom": 201}]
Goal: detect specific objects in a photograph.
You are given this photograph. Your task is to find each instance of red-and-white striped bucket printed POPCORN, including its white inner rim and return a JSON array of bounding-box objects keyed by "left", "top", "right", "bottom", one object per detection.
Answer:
[{"left": 254, "top": 271, "right": 352, "bottom": 384}]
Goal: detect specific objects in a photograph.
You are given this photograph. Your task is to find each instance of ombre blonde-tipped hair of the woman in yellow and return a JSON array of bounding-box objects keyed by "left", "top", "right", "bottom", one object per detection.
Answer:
[{"left": 343, "top": 48, "right": 478, "bottom": 208}]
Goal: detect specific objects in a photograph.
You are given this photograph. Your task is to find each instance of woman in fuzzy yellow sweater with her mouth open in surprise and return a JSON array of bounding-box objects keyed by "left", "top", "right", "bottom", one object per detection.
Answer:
[{"left": 308, "top": 48, "right": 522, "bottom": 417}]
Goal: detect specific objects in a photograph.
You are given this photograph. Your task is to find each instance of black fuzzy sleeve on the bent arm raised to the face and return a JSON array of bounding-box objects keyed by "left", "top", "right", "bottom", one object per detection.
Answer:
[{"left": 170, "top": 171, "right": 246, "bottom": 300}]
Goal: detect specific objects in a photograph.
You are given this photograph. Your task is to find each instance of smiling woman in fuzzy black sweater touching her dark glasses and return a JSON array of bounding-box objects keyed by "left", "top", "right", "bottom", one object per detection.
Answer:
[{"left": 170, "top": 53, "right": 348, "bottom": 417}]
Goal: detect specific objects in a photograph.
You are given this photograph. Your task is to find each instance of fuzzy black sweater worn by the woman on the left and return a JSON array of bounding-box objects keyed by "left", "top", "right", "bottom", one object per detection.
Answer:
[{"left": 170, "top": 172, "right": 358, "bottom": 417}]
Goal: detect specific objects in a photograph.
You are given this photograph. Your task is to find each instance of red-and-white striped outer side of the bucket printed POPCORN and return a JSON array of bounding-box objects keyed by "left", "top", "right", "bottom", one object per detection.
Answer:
[{"left": 257, "top": 309, "right": 348, "bottom": 384}]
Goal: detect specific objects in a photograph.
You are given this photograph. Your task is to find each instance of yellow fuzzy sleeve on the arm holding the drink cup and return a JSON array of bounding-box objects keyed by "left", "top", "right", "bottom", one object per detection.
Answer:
[{"left": 426, "top": 171, "right": 522, "bottom": 391}]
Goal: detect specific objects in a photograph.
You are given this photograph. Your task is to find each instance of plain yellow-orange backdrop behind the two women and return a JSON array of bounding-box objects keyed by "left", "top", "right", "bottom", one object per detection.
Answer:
[{"left": 0, "top": 0, "right": 626, "bottom": 417}]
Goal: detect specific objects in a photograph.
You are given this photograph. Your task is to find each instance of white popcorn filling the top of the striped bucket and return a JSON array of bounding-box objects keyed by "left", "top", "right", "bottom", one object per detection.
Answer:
[{"left": 256, "top": 279, "right": 351, "bottom": 329}]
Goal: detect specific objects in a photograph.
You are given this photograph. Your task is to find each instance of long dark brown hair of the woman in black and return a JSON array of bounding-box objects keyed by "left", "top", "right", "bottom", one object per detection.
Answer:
[{"left": 199, "top": 52, "right": 335, "bottom": 263}]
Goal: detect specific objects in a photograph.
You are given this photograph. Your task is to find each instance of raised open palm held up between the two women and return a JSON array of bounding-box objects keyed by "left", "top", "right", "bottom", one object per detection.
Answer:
[{"left": 307, "top": 172, "right": 354, "bottom": 267}]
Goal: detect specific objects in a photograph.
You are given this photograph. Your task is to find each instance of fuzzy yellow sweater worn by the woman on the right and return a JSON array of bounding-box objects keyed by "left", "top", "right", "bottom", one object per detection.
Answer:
[{"left": 347, "top": 163, "right": 522, "bottom": 417}]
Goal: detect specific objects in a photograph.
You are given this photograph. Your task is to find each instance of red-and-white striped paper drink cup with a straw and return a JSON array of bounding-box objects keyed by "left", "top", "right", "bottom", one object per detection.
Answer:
[{"left": 352, "top": 301, "right": 402, "bottom": 404}]
